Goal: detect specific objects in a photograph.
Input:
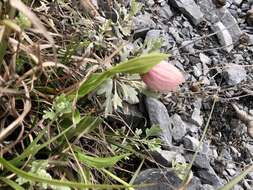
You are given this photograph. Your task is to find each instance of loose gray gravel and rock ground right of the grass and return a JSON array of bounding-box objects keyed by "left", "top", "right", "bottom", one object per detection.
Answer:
[{"left": 115, "top": 0, "right": 253, "bottom": 190}]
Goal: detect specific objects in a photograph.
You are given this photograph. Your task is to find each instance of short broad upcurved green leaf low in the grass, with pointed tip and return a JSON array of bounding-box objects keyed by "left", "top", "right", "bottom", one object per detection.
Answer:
[{"left": 76, "top": 150, "right": 131, "bottom": 169}]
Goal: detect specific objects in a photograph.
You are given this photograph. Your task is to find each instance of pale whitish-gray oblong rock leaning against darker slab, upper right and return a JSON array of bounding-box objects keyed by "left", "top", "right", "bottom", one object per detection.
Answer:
[{"left": 212, "top": 22, "right": 234, "bottom": 52}]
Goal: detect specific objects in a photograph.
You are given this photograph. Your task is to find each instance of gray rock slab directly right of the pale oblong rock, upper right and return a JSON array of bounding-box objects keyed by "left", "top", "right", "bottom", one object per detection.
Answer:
[{"left": 217, "top": 7, "right": 242, "bottom": 43}]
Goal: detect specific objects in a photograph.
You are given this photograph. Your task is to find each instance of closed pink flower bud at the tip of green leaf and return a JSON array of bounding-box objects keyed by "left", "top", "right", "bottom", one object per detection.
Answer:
[{"left": 141, "top": 61, "right": 185, "bottom": 92}]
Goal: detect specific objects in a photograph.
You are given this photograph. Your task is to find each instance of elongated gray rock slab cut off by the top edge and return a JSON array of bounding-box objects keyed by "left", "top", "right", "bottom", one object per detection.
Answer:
[{"left": 168, "top": 0, "right": 204, "bottom": 25}]
